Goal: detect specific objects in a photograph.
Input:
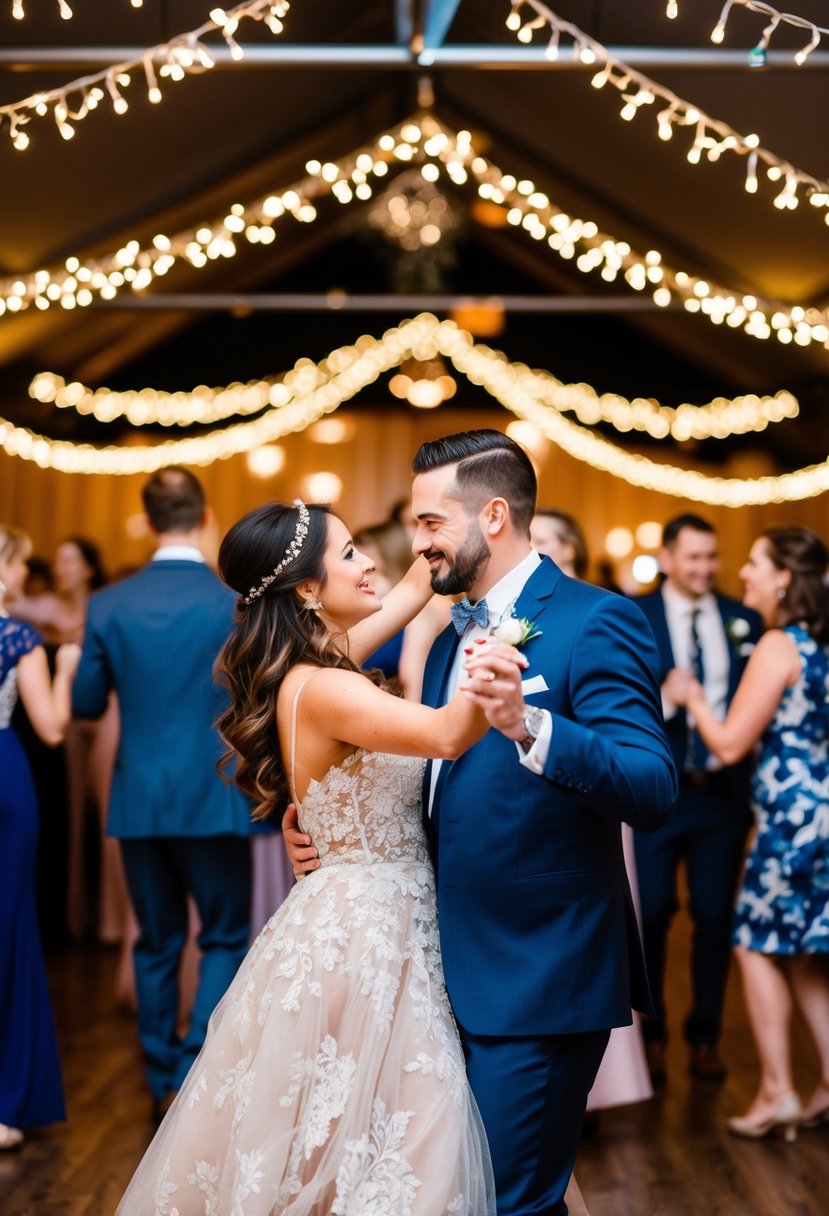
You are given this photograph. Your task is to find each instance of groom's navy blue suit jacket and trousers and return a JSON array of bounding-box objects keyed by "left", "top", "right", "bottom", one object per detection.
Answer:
[{"left": 423, "top": 558, "right": 677, "bottom": 1216}]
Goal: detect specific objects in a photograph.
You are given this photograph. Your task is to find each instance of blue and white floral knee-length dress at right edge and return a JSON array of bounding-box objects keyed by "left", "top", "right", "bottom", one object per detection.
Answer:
[{"left": 734, "top": 625, "right": 829, "bottom": 955}]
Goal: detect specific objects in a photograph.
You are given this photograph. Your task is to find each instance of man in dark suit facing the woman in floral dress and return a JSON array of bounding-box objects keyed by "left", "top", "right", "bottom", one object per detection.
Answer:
[{"left": 635, "top": 514, "right": 761, "bottom": 1083}]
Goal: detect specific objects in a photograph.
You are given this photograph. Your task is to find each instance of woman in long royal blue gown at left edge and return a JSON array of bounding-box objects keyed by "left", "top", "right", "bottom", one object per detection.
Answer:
[{"left": 0, "top": 524, "right": 80, "bottom": 1149}]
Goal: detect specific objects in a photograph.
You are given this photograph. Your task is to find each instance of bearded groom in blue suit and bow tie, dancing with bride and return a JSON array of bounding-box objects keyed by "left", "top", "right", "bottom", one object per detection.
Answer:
[{"left": 412, "top": 430, "right": 677, "bottom": 1216}]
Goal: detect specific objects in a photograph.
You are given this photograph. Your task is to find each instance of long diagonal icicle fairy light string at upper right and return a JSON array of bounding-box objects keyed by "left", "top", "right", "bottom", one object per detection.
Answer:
[{"left": 507, "top": 0, "right": 829, "bottom": 224}]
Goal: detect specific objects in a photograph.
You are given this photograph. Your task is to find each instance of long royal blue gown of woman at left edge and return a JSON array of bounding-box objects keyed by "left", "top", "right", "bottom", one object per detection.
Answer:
[{"left": 0, "top": 617, "right": 66, "bottom": 1127}]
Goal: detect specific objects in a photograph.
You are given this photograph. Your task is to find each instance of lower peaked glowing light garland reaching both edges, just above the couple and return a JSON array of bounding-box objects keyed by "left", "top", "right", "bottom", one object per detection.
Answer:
[{"left": 0, "top": 314, "right": 829, "bottom": 507}]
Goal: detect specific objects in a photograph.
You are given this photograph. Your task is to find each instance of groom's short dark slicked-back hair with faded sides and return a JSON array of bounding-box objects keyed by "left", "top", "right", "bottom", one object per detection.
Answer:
[{"left": 412, "top": 429, "right": 537, "bottom": 529}]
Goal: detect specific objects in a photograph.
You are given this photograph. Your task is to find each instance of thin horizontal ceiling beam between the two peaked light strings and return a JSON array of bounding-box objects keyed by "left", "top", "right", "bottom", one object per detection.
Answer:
[{"left": 82, "top": 292, "right": 682, "bottom": 314}]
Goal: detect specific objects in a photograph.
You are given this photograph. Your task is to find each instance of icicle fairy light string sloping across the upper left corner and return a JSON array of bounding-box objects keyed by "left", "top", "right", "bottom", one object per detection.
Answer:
[{"left": 0, "top": 0, "right": 291, "bottom": 152}]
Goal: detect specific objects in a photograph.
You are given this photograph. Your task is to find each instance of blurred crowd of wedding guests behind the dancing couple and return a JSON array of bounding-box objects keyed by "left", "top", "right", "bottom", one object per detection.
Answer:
[{"left": 0, "top": 468, "right": 829, "bottom": 1148}]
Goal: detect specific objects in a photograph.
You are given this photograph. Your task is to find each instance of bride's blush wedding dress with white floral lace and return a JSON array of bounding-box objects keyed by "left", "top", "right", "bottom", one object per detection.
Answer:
[{"left": 118, "top": 689, "right": 495, "bottom": 1216}]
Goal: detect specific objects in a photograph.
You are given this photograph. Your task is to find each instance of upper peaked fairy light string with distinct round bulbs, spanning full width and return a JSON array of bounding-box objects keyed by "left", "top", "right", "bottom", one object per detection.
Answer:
[{"left": 0, "top": 113, "right": 829, "bottom": 347}]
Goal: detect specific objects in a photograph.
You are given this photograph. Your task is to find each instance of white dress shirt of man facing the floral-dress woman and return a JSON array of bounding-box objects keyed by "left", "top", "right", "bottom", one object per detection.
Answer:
[{"left": 662, "top": 582, "right": 731, "bottom": 769}]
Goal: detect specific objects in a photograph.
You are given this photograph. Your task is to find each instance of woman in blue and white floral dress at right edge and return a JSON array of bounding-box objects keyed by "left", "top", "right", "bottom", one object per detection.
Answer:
[{"left": 670, "top": 528, "right": 829, "bottom": 1139}]
